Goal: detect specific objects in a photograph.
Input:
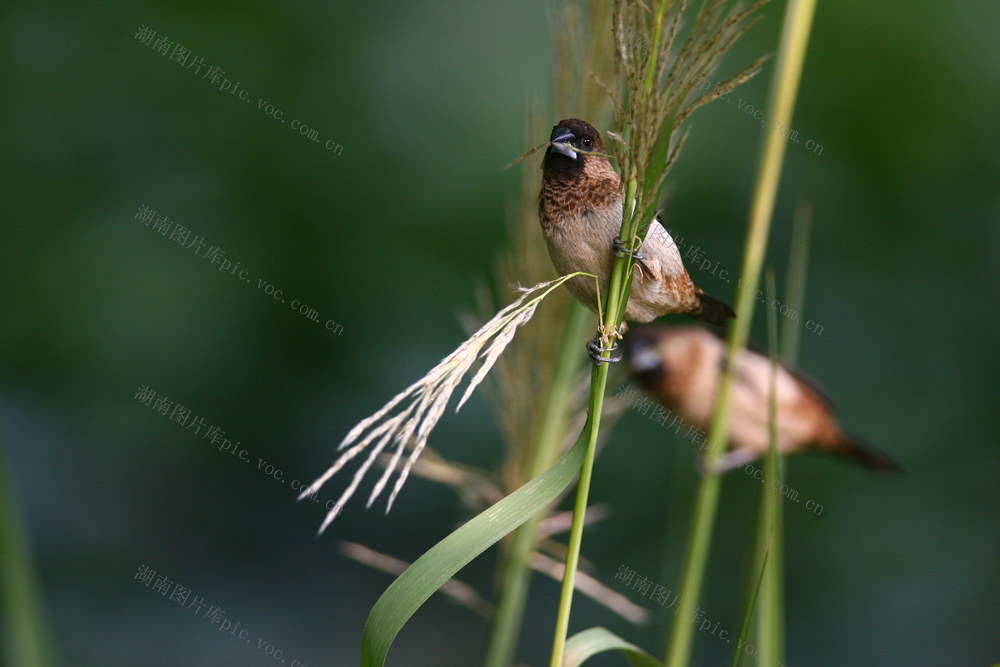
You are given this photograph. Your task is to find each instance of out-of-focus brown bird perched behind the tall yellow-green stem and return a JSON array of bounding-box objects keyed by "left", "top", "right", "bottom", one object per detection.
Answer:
[{"left": 625, "top": 325, "right": 902, "bottom": 472}]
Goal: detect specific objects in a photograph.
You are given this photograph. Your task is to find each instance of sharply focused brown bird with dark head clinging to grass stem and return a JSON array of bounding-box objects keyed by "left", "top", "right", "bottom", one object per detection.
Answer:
[{"left": 538, "top": 118, "right": 734, "bottom": 361}]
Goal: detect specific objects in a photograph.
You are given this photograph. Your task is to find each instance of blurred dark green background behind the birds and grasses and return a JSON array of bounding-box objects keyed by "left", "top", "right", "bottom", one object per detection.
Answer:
[{"left": 0, "top": 0, "right": 1000, "bottom": 667}]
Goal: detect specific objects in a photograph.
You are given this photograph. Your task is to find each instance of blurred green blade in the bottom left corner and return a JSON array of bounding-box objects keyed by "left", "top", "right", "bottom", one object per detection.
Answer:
[{"left": 0, "top": 430, "right": 52, "bottom": 667}]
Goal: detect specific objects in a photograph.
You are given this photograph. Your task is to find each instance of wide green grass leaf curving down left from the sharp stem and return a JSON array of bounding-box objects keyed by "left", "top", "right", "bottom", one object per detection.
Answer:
[{"left": 361, "top": 430, "right": 591, "bottom": 667}]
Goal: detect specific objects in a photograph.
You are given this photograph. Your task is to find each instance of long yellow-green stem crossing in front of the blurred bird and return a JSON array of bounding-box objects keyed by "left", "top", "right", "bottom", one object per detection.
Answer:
[{"left": 666, "top": 0, "right": 816, "bottom": 667}]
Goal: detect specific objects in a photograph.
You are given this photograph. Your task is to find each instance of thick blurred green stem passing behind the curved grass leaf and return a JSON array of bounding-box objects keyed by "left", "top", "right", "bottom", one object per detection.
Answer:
[{"left": 483, "top": 301, "right": 591, "bottom": 667}]
